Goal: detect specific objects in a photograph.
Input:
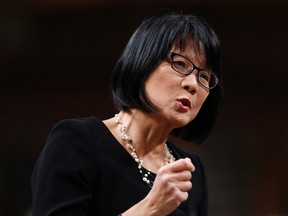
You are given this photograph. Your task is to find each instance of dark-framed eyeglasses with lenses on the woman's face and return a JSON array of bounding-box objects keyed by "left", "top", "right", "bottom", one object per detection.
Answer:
[{"left": 167, "top": 52, "right": 218, "bottom": 89}]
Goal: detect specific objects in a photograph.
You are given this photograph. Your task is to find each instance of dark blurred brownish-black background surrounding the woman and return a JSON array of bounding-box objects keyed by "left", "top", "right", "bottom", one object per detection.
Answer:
[{"left": 0, "top": 0, "right": 288, "bottom": 216}]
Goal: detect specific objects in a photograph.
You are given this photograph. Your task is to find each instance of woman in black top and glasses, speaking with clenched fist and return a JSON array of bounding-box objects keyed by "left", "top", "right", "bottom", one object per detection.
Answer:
[{"left": 32, "top": 10, "right": 221, "bottom": 216}]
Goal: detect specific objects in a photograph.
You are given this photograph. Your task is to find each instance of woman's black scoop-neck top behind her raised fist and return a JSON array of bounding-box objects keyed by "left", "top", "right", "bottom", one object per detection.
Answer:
[{"left": 32, "top": 117, "right": 207, "bottom": 216}]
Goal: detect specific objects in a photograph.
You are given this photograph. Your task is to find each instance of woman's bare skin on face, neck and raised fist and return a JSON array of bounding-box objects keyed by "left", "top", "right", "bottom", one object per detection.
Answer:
[{"left": 103, "top": 43, "right": 209, "bottom": 216}]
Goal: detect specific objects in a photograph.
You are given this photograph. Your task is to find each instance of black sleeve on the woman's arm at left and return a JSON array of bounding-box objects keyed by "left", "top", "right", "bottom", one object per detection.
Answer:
[{"left": 31, "top": 120, "right": 97, "bottom": 216}]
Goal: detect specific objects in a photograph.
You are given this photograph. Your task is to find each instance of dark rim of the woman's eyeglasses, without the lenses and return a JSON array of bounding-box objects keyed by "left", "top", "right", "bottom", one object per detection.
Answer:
[{"left": 167, "top": 52, "right": 219, "bottom": 90}]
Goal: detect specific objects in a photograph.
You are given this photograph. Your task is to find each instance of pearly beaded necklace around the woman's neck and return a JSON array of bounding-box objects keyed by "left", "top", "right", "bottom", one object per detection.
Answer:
[{"left": 115, "top": 114, "right": 175, "bottom": 188}]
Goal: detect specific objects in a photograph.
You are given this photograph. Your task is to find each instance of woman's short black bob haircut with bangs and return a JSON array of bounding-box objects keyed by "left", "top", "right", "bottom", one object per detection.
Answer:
[{"left": 111, "top": 12, "right": 222, "bottom": 144}]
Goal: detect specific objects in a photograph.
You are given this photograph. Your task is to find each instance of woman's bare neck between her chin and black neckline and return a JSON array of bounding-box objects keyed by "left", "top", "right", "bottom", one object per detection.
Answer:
[{"left": 113, "top": 111, "right": 175, "bottom": 173}]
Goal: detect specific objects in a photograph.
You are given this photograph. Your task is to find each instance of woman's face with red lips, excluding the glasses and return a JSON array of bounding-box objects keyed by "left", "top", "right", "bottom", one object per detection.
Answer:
[{"left": 145, "top": 43, "right": 209, "bottom": 128}]
